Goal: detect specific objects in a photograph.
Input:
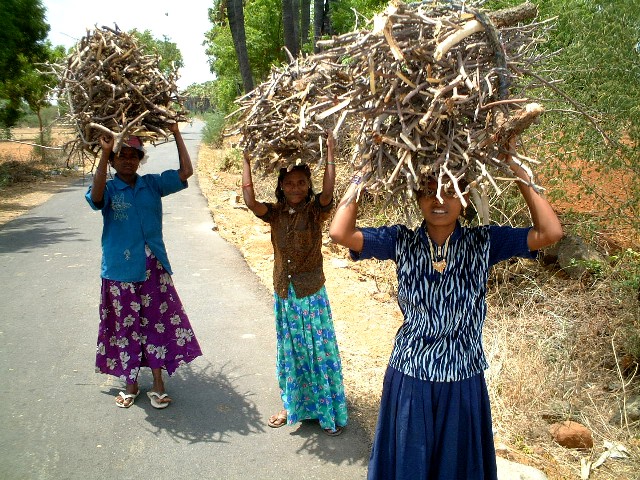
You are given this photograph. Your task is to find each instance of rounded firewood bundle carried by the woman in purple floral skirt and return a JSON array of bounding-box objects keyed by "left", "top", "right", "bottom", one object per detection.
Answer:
[{"left": 58, "top": 27, "right": 187, "bottom": 155}]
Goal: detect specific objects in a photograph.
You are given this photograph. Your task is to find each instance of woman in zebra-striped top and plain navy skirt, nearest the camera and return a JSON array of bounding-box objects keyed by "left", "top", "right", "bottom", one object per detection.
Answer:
[{"left": 330, "top": 137, "right": 563, "bottom": 480}]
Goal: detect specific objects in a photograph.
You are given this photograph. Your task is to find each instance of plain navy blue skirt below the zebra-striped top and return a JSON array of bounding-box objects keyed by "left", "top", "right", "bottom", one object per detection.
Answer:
[{"left": 367, "top": 367, "right": 498, "bottom": 480}]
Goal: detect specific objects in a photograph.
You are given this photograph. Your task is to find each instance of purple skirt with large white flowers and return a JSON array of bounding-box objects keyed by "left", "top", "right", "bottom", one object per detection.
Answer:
[{"left": 96, "top": 248, "right": 202, "bottom": 384}]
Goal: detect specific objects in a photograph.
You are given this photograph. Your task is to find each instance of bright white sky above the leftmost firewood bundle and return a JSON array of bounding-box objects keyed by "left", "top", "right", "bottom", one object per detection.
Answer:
[{"left": 42, "top": 0, "right": 214, "bottom": 89}]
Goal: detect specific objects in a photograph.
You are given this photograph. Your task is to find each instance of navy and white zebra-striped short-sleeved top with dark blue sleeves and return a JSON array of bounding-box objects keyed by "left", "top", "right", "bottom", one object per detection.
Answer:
[{"left": 351, "top": 224, "right": 535, "bottom": 382}]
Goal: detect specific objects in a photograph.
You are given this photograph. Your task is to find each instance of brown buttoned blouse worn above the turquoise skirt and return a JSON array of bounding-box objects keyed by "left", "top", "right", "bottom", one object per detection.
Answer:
[{"left": 258, "top": 195, "right": 333, "bottom": 298}]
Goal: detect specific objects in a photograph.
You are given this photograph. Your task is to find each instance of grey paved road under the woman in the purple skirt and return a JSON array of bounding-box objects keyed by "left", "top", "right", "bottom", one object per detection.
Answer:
[{"left": 0, "top": 123, "right": 369, "bottom": 480}]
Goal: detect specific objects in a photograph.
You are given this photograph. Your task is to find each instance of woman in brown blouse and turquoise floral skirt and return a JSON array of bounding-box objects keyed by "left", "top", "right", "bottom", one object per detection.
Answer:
[{"left": 242, "top": 132, "right": 347, "bottom": 436}]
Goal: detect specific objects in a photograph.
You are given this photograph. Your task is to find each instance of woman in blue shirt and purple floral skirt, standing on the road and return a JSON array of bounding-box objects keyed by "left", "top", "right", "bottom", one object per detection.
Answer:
[{"left": 86, "top": 123, "right": 202, "bottom": 408}]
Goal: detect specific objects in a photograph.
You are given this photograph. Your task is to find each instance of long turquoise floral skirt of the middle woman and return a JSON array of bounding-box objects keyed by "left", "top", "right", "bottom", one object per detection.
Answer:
[{"left": 274, "top": 284, "right": 347, "bottom": 429}]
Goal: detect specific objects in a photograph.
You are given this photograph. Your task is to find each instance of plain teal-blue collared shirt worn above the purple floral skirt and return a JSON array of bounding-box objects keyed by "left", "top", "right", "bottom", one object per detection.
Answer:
[{"left": 85, "top": 170, "right": 188, "bottom": 282}]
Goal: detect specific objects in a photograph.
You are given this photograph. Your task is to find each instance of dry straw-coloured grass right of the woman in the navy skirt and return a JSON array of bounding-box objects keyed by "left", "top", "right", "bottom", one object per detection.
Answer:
[{"left": 485, "top": 262, "right": 640, "bottom": 479}]
